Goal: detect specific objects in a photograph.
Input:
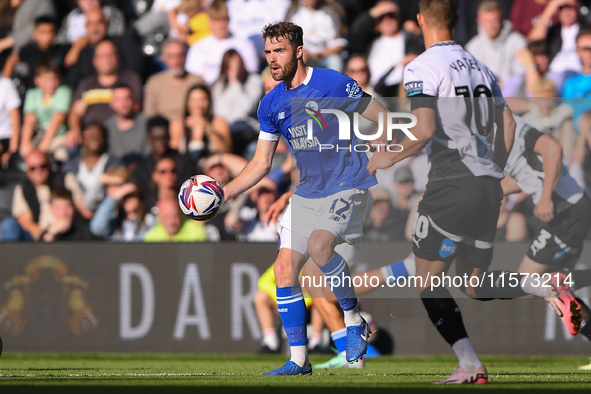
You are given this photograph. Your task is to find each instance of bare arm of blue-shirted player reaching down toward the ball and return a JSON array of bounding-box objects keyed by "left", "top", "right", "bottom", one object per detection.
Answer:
[{"left": 224, "top": 139, "right": 279, "bottom": 201}]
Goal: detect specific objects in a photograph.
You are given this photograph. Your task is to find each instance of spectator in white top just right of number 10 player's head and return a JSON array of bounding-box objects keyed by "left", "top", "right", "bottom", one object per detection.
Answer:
[{"left": 466, "top": 0, "right": 527, "bottom": 85}]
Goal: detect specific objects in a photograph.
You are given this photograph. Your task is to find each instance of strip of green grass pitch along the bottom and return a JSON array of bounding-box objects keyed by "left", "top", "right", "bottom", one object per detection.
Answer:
[{"left": 0, "top": 353, "right": 591, "bottom": 394}]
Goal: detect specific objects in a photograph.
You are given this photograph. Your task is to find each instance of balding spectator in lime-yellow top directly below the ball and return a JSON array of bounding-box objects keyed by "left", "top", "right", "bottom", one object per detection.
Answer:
[{"left": 144, "top": 197, "right": 207, "bottom": 242}]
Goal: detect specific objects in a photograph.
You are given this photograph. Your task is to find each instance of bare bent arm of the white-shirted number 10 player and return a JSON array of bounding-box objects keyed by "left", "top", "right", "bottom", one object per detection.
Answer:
[{"left": 367, "top": 107, "right": 435, "bottom": 175}]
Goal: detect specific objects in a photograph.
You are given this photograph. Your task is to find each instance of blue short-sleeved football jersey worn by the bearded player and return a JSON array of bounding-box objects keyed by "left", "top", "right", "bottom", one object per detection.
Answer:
[{"left": 258, "top": 67, "right": 377, "bottom": 198}]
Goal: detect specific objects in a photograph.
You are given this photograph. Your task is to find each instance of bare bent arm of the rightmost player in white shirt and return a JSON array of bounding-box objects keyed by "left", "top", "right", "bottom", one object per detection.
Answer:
[{"left": 534, "top": 135, "right": 562, "bottom": 222}]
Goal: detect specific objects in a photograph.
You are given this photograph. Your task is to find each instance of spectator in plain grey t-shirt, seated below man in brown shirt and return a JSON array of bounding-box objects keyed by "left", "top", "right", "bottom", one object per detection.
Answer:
[{"left": 104, "top": 83, "right": 148, "bottom": 162}]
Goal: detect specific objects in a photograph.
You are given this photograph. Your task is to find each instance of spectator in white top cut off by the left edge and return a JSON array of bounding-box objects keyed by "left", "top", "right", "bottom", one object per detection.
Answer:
[{"left": 0, "top": 73, "right": 21, "bottom": 168}]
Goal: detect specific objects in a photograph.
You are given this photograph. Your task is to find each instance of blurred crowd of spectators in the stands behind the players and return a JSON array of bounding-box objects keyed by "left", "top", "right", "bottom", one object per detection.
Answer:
[{"left": 0, "top": 0, "right": 591, "bottom": 242}]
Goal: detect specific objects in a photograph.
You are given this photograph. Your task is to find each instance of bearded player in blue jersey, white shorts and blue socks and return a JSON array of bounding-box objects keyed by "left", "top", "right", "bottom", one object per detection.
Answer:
[{"left": 224, "top": 22, "right": 387, "bottom": 375}]
